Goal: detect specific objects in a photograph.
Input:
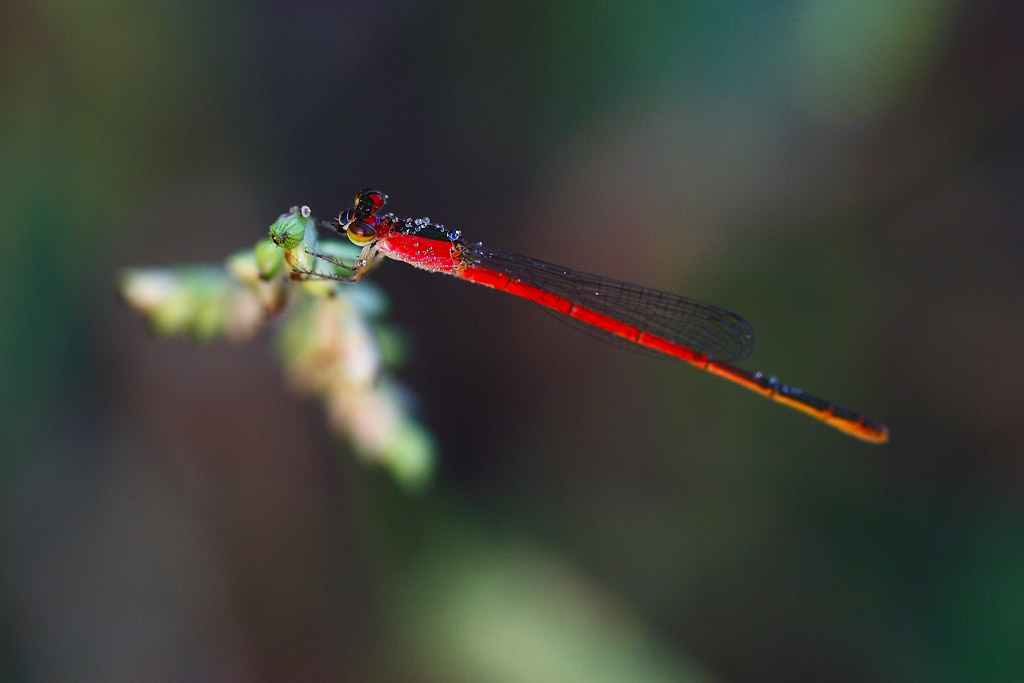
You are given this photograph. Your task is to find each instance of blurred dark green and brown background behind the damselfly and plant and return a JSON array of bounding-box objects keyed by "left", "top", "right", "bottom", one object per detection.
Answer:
[{"left": 0, "top": 0, "right": 1024, "bottom": 681}]
